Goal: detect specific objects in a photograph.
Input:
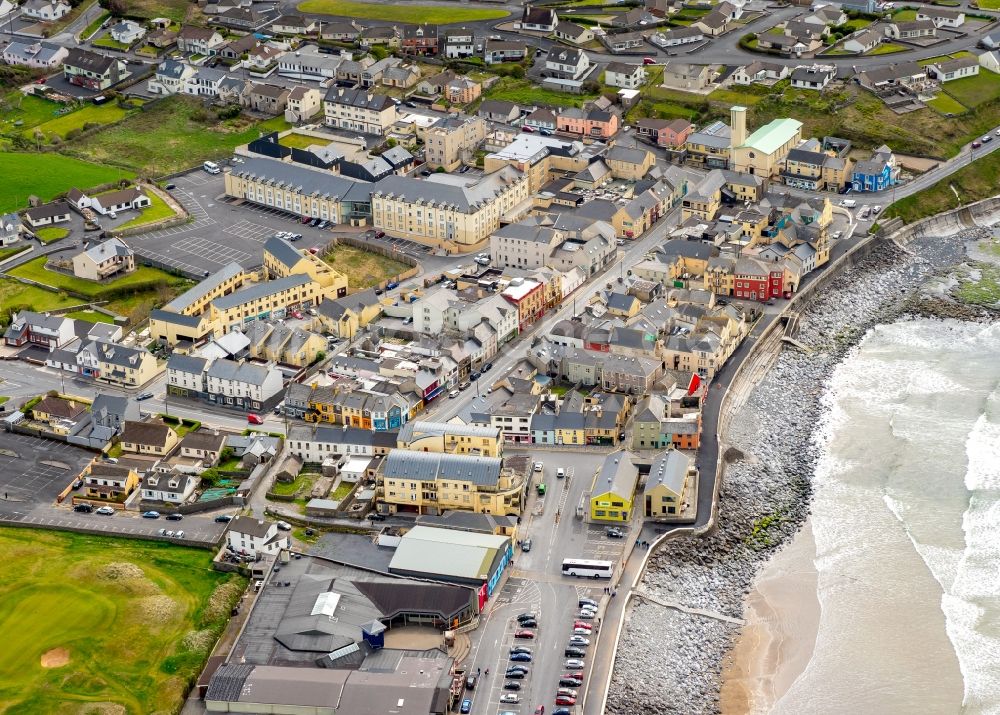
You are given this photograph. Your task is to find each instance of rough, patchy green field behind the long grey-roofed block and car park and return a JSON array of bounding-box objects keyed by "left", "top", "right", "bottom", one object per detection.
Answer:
[{"left": 67, "top": 96, "right": 291, "bottom": 176}]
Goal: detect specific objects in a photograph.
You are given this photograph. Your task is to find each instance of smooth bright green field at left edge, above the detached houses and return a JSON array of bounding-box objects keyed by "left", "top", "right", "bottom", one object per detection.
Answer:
[{"left": 0, "top": 152, "right": 135, "bottom": 212}]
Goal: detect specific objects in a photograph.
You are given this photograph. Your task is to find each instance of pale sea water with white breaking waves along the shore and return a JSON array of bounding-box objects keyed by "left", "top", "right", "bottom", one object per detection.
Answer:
[{"left": 773, "top": 320, "right": 1000, "bottom": 715}]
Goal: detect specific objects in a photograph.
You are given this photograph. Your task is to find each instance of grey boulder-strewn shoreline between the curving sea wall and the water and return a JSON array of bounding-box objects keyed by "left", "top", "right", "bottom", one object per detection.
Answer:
[{"left": 607, "top": 229, "right": 996, "bottom": 715}]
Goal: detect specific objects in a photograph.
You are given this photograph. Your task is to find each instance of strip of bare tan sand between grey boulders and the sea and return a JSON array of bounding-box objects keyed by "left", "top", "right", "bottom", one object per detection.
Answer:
[{"left": 719, "top": 521, "right": 820, "bottom": 715}]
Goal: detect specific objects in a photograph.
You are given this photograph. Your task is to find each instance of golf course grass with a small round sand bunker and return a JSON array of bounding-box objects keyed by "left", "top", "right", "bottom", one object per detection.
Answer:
[{"left": 0, "top": 517, "right": 245, "bottom": 714}]
